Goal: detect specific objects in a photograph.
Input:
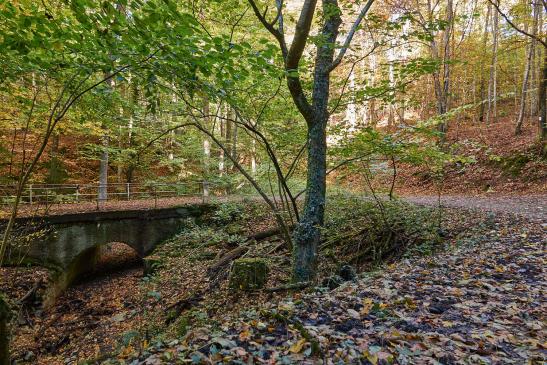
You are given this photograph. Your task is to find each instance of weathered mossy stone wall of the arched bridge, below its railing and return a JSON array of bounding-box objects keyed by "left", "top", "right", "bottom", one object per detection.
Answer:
[{"left": 0, "top": 204, "right": 214, "bottom": 297}]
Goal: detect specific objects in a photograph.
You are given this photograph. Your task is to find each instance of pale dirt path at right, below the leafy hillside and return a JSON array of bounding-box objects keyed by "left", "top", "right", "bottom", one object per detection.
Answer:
[{"left": 404, "top": 195, "right": 547, "bottom": 222}]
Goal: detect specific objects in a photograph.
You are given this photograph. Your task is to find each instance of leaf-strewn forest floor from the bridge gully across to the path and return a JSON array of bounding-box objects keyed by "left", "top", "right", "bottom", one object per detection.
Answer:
[{"left": 0, "top": 195, "right": 547, "bottom": 364}]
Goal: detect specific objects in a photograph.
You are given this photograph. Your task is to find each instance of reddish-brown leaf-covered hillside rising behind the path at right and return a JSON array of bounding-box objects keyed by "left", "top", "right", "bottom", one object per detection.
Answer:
[{"left": 392, "top": 115, "right": 547, "bottom": 196}]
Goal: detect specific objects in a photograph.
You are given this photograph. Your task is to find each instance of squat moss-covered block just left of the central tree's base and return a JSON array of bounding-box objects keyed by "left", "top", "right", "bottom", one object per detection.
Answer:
[{"left": 229, "top": 258, "right": 270, "bottom": 290}]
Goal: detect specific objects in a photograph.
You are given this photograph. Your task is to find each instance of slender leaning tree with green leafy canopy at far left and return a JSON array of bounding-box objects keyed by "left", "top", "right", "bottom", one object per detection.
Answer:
[{"left": 0, "top": 0, "right": 209, "bottom": 266}]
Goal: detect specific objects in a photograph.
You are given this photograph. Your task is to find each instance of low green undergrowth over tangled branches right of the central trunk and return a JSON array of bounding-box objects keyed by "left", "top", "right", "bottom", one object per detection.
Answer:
[{"left": 322, "top": 194, "right": 441, "bottom": 264}]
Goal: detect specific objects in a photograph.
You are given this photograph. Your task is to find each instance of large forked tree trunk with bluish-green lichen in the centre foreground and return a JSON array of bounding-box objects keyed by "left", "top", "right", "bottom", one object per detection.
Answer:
[{"left": 248, "top": 0, "right": 373, "bottom": 282}]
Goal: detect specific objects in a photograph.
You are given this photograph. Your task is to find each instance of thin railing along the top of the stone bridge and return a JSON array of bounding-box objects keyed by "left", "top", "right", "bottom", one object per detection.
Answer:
[{"left": 0, "top": 181, "right": 246, "bottom": 206}]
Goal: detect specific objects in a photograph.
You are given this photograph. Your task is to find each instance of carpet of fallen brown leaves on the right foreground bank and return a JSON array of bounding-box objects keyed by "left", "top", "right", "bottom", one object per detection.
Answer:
[{"left": 113, "top": 211, "right": 547, "bottom": 364}]
